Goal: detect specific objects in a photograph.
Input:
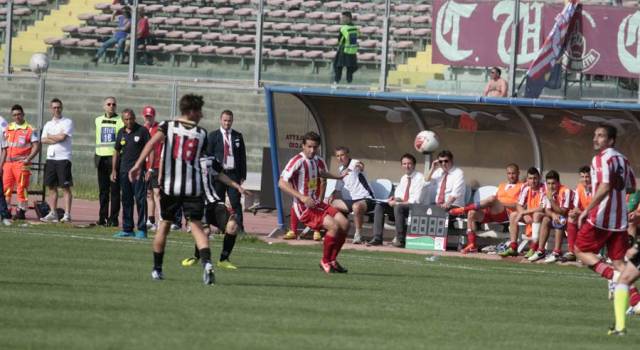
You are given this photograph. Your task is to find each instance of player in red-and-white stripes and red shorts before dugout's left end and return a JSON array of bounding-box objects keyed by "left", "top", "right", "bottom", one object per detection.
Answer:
[{"left": 278, "top": 131, "right": 349, "bottom": 273}]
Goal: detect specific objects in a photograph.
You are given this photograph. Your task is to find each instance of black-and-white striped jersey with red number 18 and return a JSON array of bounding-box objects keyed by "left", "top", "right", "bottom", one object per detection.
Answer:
[{"left": 158, "top": 120, "right": 207, "bottom": 196}]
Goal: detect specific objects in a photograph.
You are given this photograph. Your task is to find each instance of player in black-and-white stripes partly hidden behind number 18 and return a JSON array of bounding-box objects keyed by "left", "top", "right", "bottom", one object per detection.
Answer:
[{"left": 182, "top": 156, "right": 251, "bottom": 270}]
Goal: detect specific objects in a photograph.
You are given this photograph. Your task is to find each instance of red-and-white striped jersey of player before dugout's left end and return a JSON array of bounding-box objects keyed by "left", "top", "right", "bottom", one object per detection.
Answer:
[{"left": 280, "top": 152, "right": 327, "bottom": 217}]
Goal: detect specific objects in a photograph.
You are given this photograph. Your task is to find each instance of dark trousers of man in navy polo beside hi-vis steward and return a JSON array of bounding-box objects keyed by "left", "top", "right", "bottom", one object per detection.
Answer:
[{"left": 120, "top": 169, "right": 147, "bottom": 232}]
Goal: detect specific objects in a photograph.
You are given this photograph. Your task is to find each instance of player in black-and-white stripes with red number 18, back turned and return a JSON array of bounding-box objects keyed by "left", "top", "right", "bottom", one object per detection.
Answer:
[{"left": 129, "top": 94, "right": 215, "bottom": 284}]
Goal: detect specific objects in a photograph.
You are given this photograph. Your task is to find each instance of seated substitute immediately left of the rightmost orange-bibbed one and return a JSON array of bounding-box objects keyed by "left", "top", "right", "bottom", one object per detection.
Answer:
[{"left": 529, "top": 170, "right": 573, "bottom": 264}]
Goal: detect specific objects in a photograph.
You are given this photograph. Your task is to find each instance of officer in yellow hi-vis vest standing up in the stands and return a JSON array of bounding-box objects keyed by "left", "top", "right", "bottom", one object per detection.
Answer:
[{"left": 333, "top": 11, "right": 358, "bottom": 84}]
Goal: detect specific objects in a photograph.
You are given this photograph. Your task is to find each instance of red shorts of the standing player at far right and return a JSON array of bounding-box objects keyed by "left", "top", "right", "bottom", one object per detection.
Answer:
[{"left": 575, "top": 221, "right": 629, "bottom": 260}]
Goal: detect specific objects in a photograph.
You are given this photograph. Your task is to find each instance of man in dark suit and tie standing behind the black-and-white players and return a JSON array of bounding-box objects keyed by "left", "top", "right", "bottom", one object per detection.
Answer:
[{"left": 207, "top": 110, "right": 247, "bottom": 231}]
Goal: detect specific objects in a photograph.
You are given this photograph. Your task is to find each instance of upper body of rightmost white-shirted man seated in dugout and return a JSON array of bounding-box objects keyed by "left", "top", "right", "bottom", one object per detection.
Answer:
[{"left": 426, "top": 150, "right": 465, "bottom": 209}]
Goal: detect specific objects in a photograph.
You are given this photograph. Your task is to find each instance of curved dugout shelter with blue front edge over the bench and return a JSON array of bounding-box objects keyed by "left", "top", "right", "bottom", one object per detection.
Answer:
[{"left": 262, "top": 86, "right": 640, "bottom": 229}]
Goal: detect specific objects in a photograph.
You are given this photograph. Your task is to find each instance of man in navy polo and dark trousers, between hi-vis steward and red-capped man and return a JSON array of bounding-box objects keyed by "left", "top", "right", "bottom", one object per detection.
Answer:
[{"left": 111, "top": 108, "right": 153, "bottom": 239}]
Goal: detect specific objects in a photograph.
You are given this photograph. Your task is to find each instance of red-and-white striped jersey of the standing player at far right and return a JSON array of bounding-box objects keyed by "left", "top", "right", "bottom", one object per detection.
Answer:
[{"left": 587, "top": 148, "right": 636, "bottom": 231}]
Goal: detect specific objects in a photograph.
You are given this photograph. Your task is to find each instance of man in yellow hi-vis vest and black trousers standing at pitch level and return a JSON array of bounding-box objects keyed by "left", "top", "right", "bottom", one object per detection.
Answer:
[{"left": 95, "top": 97, "right": 124, "bottom": 227}]
